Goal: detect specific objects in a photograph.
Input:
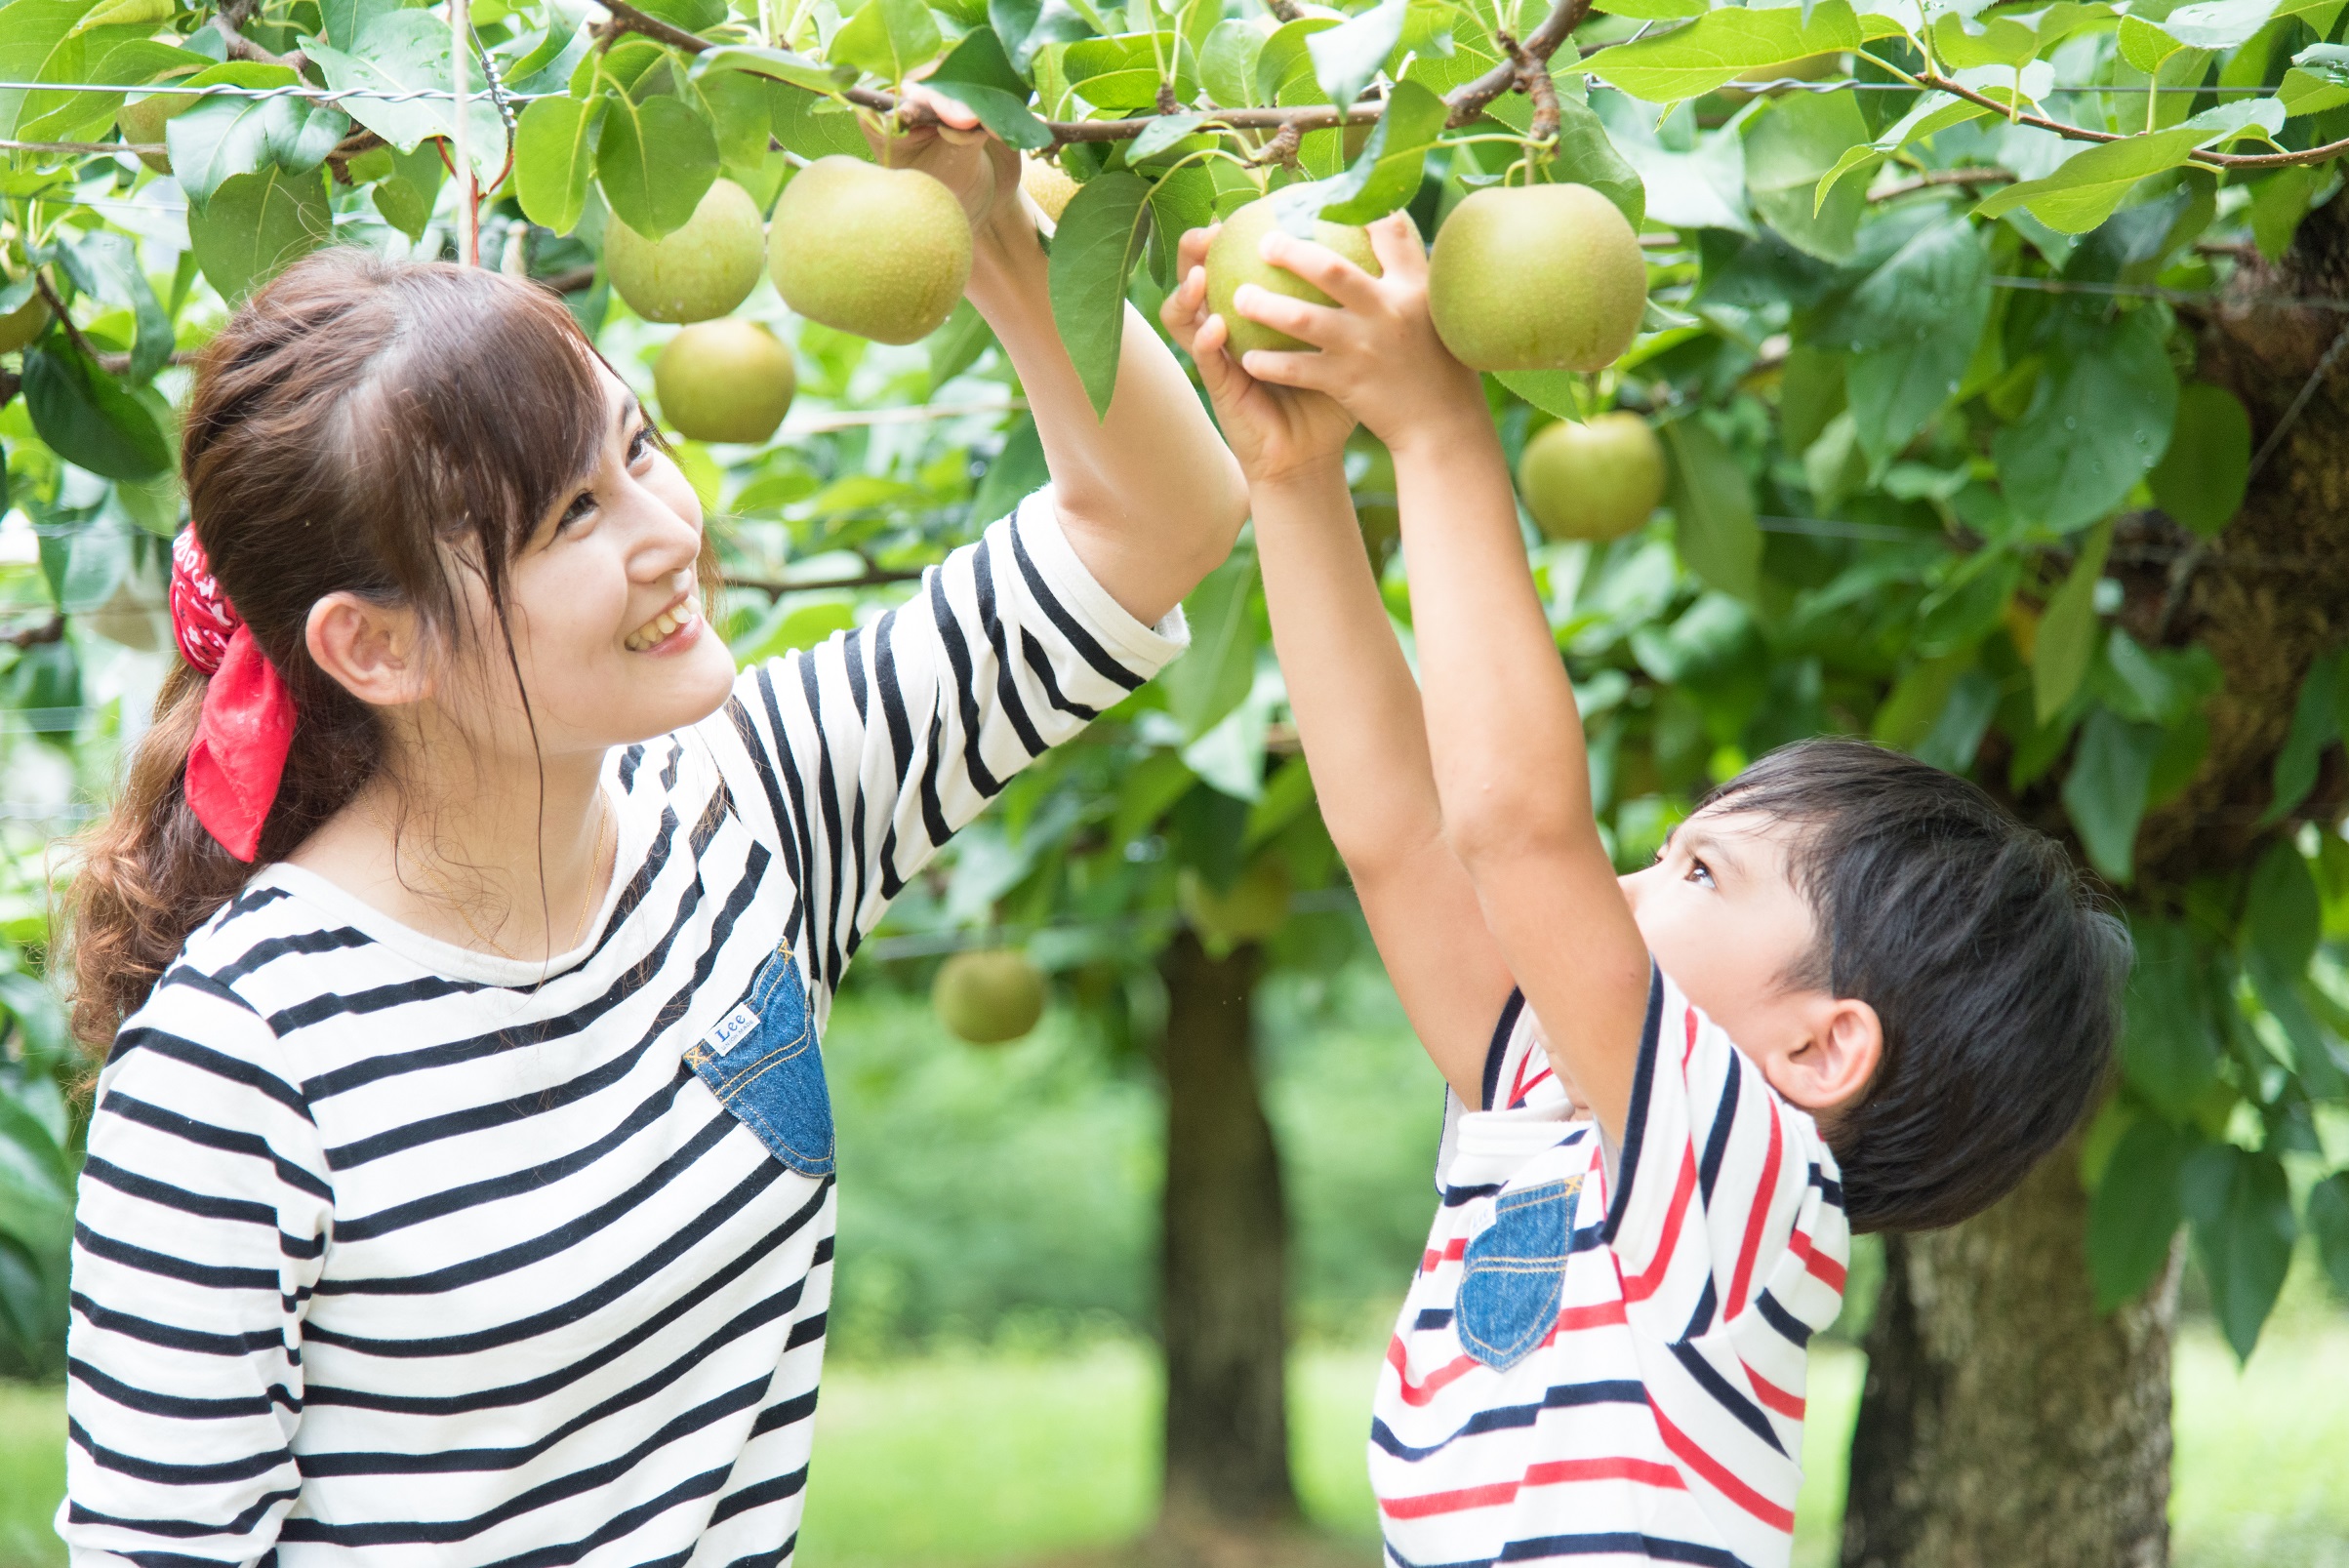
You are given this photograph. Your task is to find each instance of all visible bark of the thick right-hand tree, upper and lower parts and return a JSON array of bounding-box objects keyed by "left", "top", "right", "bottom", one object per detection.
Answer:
[{"left": 1843, "top": 195, "right": 2349, "bottom": 1568}]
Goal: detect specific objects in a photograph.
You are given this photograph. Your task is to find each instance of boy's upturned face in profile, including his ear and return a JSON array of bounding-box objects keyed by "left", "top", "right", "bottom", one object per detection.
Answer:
[{"left": 1618, "top": 808, "right": 1882, "bottom": 1112}]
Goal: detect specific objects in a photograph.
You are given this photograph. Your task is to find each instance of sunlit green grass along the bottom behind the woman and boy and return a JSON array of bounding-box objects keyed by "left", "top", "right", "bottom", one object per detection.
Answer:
[{"left": 0, "top": 1317, "right": 2349, "bottom": 1568}]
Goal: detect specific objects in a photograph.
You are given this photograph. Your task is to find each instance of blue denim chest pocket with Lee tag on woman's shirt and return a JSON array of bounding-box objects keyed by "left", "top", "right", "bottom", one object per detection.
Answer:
[{"left": 686, "top": 948, "right": 831, "bottom": 1176}]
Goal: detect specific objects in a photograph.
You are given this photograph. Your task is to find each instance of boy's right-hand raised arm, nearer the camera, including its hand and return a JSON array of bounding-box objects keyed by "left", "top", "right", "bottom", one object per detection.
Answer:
[{"left": 1245, "top": 214, "right": 1649, "bottom": 1146}]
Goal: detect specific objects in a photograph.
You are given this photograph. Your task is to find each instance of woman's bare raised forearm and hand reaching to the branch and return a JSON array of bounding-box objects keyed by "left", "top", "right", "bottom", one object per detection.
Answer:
[{"left": 890, "top": 89, "right": 1247, "bottom": 624}]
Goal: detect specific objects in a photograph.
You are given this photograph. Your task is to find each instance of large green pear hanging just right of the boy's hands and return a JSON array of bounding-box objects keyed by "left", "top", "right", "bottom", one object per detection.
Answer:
[{"left": 1428, "top": 185, "right": 1646, "bottom": 371}]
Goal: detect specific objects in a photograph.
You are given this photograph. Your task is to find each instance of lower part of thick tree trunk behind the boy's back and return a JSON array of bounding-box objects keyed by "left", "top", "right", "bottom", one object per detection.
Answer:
[{"left": 1843, "top": 1144, "right": 2185, "bottom": 1568}]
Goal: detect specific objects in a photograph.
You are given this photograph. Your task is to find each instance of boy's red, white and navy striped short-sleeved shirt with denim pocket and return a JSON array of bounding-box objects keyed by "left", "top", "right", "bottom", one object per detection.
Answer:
[{"left": 1369, "top": 974, "right": 1851, "bottom": 1568}]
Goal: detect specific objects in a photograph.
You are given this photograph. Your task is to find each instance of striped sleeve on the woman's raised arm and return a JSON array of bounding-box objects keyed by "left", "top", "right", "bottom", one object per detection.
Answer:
[{"left": 711, "top": 491, "right": 1187, "bottom": 990}]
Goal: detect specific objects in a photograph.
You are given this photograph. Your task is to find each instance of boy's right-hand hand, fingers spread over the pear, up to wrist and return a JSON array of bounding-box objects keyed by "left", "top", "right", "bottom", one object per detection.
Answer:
[{"left": 1234, "top": 212, "right": 1491, "bottom": 453}]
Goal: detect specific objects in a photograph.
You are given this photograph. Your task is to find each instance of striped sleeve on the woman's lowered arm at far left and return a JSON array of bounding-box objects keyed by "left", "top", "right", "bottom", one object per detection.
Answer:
[{"left": 57, "top": 970, "right": 334, "bottom": 1566}]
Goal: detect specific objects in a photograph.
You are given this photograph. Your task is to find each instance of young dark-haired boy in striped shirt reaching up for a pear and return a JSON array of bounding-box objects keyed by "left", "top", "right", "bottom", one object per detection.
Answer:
[{"left": 1165, "top": 214, "right": 2126, "bottom": 1568}]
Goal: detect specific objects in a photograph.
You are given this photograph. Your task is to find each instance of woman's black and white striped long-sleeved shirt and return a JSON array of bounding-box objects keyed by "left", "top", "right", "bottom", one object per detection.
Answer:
[{"left": 59, "top": 493, "right": 1184, "bottom": 1568}]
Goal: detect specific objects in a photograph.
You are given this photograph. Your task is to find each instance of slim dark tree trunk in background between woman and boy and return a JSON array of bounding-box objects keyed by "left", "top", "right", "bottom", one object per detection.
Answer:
[{"left": 1158, "top": 932, "right": 1297, "bottom": 1556}]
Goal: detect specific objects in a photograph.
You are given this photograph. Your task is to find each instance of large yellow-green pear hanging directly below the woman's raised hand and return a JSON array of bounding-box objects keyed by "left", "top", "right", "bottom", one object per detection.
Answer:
[{"left": 766, "top": 155, "right": 970, "bottom": 342}]
